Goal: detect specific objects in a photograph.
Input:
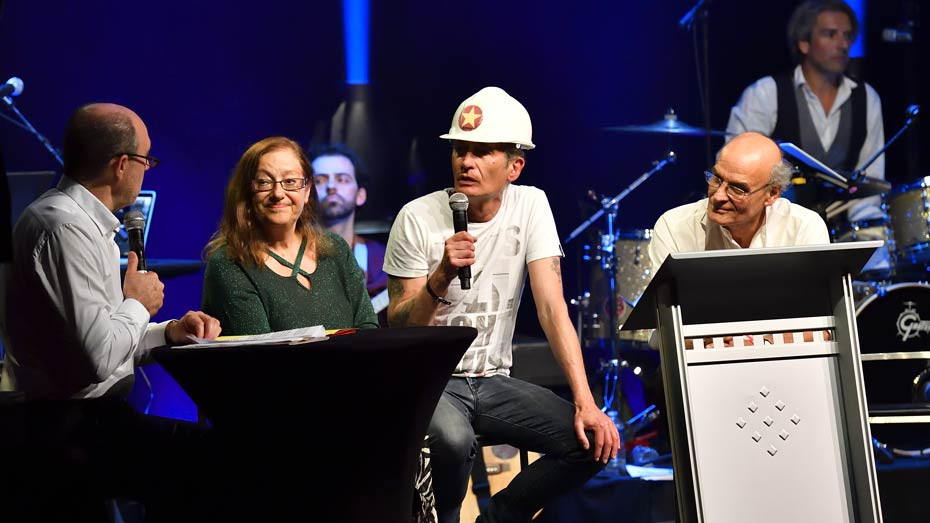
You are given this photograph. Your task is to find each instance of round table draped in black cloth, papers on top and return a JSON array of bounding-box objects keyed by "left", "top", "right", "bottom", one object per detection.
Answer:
[{"left": 154, "top": 327, "right": 477, "bottom": 523}]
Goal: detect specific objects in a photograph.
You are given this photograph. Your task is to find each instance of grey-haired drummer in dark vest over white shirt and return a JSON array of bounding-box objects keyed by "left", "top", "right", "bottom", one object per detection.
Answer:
[{"left": 727, "top": 0, "right": 885, "bottom": 268}]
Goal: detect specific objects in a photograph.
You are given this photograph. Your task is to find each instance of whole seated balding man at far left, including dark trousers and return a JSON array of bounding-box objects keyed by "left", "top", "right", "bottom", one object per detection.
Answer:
[{"left": 0, "top": 104, "right": 221, "bottom": 521}]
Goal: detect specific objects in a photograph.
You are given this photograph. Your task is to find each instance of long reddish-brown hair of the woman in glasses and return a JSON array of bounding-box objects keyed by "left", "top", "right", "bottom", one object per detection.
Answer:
[{"left": 204, "top": 136, "right": 332, "bottom": 267}]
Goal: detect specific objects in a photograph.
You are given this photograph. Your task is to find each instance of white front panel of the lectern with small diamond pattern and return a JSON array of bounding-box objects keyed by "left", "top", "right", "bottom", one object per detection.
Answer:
[{"left": 688, "top": 356, "right": 856, "bottom": 523}]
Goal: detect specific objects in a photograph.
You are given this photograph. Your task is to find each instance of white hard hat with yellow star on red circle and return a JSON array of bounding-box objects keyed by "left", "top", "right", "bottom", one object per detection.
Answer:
[{"left": 440, "top": 87, "right": 536, "bottom": 150}]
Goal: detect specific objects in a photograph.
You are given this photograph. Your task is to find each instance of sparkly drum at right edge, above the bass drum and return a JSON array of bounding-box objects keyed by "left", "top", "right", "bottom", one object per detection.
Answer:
[{"left": 885, "top": 176, "right": 930, "bottom": 264}]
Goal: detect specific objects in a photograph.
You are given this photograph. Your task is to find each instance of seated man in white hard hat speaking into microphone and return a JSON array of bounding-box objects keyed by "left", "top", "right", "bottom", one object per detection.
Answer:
[{"left": 384, "top": 87, "right": 620, "bottom": 522}]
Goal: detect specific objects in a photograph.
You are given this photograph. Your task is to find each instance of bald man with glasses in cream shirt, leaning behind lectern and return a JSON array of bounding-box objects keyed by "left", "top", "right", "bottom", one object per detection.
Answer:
[{"left": 649, "top": 133, "right": 830, "bottom": 271}]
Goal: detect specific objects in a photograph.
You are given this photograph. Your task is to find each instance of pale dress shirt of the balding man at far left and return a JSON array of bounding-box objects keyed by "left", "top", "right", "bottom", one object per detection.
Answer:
[{"left": 4, "top": 176, "right": 166, "bottom": 399}]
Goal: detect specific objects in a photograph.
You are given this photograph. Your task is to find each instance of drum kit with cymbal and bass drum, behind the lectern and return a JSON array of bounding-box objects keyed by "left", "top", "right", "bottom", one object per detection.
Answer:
[{"left": 565, "top": 106, "right": 930, "bottom": 458}]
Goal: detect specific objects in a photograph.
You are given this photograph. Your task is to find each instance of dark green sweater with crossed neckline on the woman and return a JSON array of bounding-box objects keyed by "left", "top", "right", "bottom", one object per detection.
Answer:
[{"left": 202, "top": 233, "right": 378, "bottom": 335}]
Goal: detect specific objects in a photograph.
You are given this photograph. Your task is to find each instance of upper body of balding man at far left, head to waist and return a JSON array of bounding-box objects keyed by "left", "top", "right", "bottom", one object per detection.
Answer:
[{"left": 3, "top": 104, "right": 220, "bottom": 399}]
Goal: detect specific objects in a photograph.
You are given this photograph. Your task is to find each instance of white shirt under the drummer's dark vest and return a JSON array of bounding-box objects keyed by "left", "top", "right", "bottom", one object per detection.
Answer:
[{"left": 727, "top": 65, "right": 885, "bottom": 221}]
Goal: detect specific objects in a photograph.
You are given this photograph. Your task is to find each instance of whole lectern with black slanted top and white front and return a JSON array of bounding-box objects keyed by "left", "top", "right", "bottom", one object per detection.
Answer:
[{"left": 623, "top": 242, "right": 882, "bottom": 523}]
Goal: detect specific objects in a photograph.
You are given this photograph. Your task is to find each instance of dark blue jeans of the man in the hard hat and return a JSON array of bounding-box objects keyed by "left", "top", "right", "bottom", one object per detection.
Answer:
[{"left": 428, "top": 376, "right": 604, "bottom": 523}]
